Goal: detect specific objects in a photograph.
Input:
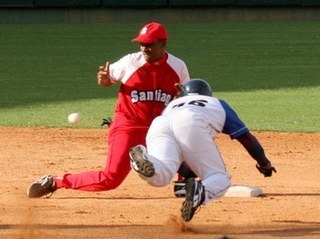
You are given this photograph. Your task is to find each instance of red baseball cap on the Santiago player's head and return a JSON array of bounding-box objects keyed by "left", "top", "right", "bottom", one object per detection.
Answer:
[{"left": 132, "top": 22, "right": 168, "bottom": 44}]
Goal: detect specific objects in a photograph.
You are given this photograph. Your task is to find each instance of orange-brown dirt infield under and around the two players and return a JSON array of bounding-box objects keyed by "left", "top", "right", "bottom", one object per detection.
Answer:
[{"left": 0, "top": 127, "right": 320, "bottom": 239}]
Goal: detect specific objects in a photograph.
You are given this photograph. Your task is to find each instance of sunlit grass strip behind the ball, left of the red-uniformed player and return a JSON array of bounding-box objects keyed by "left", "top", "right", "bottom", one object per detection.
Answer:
[{"left": 1, "top": 99, "right": 115, "bottom": 128}]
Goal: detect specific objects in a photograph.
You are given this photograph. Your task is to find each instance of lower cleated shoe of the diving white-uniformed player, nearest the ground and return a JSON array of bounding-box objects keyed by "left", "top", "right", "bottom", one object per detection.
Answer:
[{"left": 180, "top": 178, "right": 205, "bottom": 222}]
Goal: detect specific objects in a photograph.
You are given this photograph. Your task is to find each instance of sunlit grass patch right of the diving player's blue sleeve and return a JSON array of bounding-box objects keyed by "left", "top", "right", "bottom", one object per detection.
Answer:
[{"left": 215, "top": 87, "right": 320, "bottom": 132}]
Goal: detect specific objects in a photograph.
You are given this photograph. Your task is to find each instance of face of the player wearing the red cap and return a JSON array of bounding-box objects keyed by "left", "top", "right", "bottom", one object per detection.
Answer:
[{"left": 140, "top": 40, "right": 165, "bottom": 62}]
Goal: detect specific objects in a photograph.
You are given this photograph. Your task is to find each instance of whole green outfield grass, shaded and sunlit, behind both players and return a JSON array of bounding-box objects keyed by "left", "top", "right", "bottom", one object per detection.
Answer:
[{"left": 0, "top": 22, "right": 320, "bottom": 132}]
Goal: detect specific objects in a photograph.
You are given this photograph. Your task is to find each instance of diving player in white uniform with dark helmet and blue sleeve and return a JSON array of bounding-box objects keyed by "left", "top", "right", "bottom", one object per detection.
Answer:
[{"left": 130, "top": 79, "right": 276, "bottom": 221}]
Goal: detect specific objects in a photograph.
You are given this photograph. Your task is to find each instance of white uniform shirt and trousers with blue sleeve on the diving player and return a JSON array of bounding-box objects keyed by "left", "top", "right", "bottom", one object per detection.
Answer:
[{"left": 146, "top": 95, "right": 248, "bottom": 203}]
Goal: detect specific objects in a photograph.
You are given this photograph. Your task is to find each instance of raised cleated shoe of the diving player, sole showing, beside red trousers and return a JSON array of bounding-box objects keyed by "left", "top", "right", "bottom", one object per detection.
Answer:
[{"left": 129, "top": 145, "right": 155, "bottom": 178}]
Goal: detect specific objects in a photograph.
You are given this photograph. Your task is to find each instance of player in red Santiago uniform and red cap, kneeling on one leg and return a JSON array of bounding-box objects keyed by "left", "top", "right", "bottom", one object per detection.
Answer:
[{"left": 27, "top": 22, "right": 189, "bottom": 198}]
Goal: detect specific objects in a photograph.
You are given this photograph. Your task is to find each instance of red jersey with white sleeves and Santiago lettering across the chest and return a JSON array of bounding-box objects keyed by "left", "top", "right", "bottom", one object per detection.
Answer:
[{"left": 110, "top": 52, "right": 190, "bottom": 127}]
